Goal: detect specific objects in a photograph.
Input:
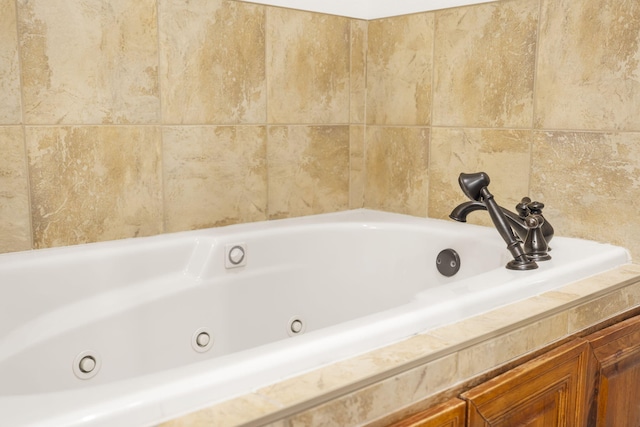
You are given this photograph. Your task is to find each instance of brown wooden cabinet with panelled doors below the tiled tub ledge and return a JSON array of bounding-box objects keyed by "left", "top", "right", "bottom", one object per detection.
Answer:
[{"left": 393, "top": 316, "right": 640, "bottom": 427}]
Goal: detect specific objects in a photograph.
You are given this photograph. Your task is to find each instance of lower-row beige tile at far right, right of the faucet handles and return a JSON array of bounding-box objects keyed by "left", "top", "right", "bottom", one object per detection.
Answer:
[{"left": 531, "top": 132, "right": 640, "bottom": 257}]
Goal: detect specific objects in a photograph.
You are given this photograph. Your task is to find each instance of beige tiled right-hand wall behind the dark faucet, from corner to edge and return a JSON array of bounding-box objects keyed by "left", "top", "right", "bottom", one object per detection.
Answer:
[{"left": 365, "top": 0, "right": 640, "bottom": 260}]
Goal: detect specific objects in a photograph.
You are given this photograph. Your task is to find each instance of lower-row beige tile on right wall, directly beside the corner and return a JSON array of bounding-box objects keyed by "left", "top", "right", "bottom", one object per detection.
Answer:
[{"left": 365, "top": 126, "right": 429, "bottom": 217}]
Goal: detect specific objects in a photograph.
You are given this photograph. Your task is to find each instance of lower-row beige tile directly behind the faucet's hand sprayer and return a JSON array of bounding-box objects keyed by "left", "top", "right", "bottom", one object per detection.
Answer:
[{"left": 429, "top": 128, "right": 531, "bottom": 225}]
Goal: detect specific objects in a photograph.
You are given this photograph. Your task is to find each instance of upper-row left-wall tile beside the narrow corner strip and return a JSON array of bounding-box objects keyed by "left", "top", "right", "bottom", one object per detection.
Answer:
[{"left": 267, "top": 7, "right": 351, "bottom": 124}]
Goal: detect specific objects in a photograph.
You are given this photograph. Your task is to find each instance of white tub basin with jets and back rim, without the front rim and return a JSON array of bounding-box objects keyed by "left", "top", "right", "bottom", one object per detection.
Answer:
[{"left": 0, "top": 211, "right": 508, "bottom": 395}]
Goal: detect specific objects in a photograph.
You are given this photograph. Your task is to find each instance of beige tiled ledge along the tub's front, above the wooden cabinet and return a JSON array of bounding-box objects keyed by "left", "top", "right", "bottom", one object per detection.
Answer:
[{"left": 160, "top": 264, "right": 640, "bottom": 427}]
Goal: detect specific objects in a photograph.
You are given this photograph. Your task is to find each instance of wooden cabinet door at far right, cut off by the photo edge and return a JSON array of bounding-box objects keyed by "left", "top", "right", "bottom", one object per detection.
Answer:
[{"left": 587, "top": 317, "right": 640, "bottom": 427}]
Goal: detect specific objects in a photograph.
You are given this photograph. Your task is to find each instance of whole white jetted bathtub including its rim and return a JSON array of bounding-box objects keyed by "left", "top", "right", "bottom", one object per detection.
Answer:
[{"left": 0, "top": 210, "right": 630, "bottom": 427}]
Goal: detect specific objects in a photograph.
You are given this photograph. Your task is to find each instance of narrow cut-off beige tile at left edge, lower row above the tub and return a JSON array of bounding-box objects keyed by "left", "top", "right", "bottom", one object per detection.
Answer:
[{"left": 0, "top": 128, "right": 31, "bottom": 253}]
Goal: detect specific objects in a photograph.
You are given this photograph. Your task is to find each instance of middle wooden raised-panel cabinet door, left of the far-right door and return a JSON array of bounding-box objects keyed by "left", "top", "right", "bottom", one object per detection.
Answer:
[{"left": 462, "top": 339, "right": 597, "bottom": 427}]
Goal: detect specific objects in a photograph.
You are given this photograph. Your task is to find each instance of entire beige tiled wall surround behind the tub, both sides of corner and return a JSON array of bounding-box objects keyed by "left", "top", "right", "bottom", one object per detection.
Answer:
[{"left": 0, "top": 0, "right": 640, "bottom": 255}]
